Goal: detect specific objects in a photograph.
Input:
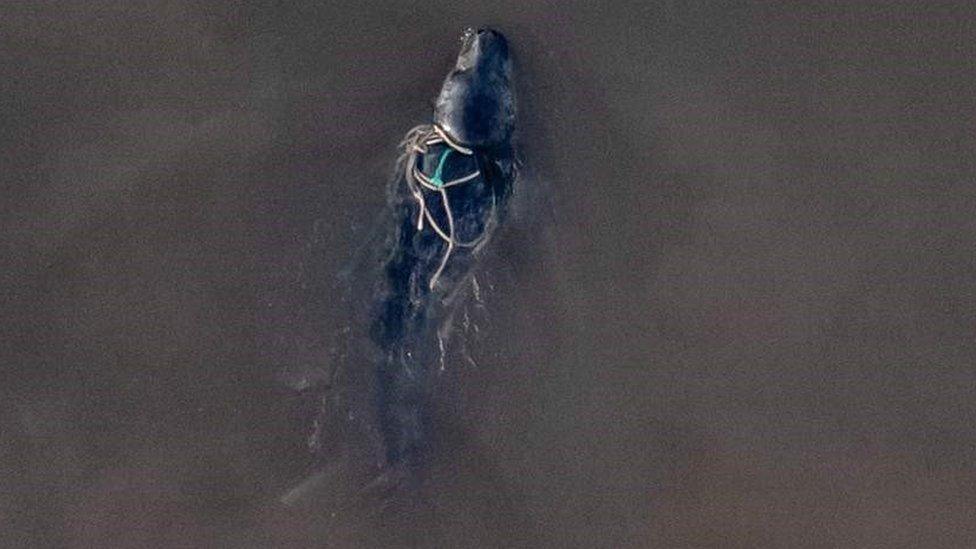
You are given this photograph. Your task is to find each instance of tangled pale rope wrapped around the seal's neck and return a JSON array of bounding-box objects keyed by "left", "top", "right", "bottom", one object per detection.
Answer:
[{"left": 403, "top": 125, "right": 495, "bottom": 290}]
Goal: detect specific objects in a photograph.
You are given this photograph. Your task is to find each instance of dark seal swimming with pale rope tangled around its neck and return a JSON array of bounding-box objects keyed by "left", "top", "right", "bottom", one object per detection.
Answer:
[{"left": 370, "top": 29, "right": 516, "bottom": 466}]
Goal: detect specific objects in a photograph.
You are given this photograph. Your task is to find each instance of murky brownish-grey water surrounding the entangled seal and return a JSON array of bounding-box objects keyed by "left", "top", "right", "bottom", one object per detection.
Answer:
[{"left": 0, "top": 1, "right": 976, "bottom": 547}]
